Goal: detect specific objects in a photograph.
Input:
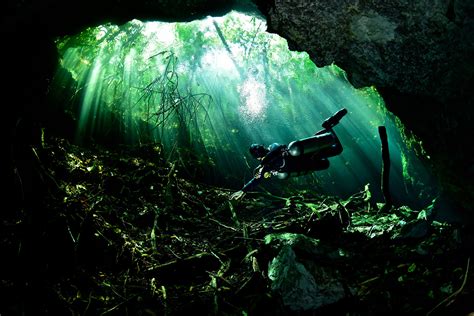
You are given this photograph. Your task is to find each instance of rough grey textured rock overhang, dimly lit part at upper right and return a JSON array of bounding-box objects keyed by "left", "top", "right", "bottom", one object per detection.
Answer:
[{"left": 260, "top": 0, "right": 474, "bottom": 102}]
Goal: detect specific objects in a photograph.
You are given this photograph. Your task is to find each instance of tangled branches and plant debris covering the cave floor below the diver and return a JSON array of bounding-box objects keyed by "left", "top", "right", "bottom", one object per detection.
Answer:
[{"left": 0, "top": 133, "right": 474, "bottom": 315}]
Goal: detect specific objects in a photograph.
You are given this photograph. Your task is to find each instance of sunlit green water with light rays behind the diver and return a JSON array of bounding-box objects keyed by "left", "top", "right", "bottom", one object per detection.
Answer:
[{"left": 52, "top": 11, "right": 436, "bottom": 206}]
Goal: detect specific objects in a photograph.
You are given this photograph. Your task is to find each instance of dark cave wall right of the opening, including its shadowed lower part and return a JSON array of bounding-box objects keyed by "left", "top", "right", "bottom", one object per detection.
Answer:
[{"left": 256, "top": 0, "right": 474, "bottom": 212}]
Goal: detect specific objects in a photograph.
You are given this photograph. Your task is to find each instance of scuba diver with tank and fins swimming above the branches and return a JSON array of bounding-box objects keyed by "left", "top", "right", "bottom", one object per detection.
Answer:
[{"left": 230, "top": 109, "right": 347, "bottom": 200}]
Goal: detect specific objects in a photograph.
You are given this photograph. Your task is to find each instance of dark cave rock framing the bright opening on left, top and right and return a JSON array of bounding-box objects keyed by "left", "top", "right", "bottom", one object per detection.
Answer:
[{"left": 1, "top": 0, "right": 474, "bottom": 215}]
